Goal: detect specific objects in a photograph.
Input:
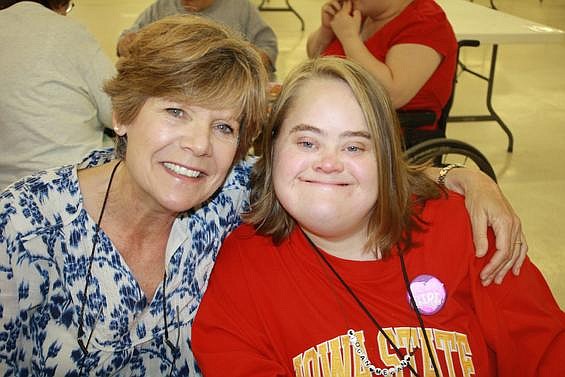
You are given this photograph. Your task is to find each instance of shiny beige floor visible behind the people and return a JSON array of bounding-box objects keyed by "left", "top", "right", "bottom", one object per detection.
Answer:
[{"left": 70, "top": 0, "right": 565, "bottom": 308}]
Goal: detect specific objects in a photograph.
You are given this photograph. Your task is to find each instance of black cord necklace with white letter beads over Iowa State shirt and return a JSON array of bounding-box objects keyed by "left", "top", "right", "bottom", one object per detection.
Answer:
[{"left": 300, "top": 228, "right": 439, "bottom": 377}]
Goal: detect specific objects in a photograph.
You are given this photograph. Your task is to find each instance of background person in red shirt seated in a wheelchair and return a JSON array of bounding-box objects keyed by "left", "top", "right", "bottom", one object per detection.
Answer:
[{"left": 307, "top": 0, "right": 457, "bottom": 147}]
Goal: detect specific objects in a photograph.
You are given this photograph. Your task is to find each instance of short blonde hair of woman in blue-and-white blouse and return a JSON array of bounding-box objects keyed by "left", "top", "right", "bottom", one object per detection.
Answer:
[{"left": 104, "top": 15, "right": 267, "bottom": 162}]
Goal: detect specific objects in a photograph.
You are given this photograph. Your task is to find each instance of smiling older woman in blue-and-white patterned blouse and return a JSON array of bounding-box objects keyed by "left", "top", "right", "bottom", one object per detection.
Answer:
[{"left": 0, "top": 16, "right": 520, "bottom": 376}]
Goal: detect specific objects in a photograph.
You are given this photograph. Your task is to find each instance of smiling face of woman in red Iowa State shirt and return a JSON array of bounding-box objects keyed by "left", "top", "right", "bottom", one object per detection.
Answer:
[{"left": 273, "top": 78, "right": 378, "bottom": 239}]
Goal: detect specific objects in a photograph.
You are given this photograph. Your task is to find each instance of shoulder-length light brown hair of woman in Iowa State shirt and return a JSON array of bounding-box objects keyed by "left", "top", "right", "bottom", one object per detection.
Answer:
[{"left": 245, "top": 57, "right": 440, "bottom": 257}]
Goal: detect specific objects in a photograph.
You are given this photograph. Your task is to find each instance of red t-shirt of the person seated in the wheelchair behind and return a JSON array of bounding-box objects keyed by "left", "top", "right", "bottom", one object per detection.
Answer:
[{"left": 322, "top": 0, "right": 457, "bottom": 131}]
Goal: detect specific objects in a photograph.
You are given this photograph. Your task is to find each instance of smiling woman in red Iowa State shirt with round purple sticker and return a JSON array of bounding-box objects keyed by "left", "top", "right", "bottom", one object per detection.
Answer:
[{"left": 192, "top": 58, "right": 565, "bottom": 377}]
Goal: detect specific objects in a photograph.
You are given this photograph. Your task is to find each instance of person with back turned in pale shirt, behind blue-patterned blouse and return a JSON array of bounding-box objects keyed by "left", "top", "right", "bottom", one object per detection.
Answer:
[{"left": 0, "top": 0, "right": 115, "bottom": 190}]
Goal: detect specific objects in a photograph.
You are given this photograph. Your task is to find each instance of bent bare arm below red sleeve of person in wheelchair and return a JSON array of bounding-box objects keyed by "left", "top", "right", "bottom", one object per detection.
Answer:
[{"left": 331, "top": 1, "right": 442, "bottom": 108}]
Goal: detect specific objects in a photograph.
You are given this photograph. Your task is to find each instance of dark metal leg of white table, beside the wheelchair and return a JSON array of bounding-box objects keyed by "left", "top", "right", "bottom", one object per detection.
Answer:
[{"left": 447, "top": 44, "right": 514, "bottom": 152}]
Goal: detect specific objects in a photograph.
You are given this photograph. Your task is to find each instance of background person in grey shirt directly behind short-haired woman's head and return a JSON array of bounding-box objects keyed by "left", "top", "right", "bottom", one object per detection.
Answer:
[{"left": 118, "top": 0, "right": 278, "bottom": 72}]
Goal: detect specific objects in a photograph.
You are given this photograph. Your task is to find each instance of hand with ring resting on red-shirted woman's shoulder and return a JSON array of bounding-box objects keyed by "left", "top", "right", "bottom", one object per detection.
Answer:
[{"left": 445, "top": 169, "right": 528, "bottom": 286}]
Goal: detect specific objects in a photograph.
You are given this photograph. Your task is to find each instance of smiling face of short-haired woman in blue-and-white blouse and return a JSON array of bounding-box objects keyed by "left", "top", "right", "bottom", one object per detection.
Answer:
[{"left": 116, "top": 98, "right": 239, "bottom": 213}]
